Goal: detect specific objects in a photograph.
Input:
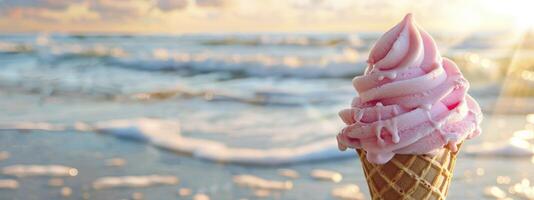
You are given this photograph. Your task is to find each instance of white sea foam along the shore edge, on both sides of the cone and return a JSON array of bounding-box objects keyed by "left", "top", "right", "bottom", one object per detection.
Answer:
[{"left": 4, "top": 118, "right": 534, "bottom": 164}]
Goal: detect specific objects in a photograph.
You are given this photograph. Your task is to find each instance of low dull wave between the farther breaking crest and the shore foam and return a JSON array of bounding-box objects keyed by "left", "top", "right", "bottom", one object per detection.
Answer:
[{"left": 0, "top": 77, "right": 337, "bottom": 106}]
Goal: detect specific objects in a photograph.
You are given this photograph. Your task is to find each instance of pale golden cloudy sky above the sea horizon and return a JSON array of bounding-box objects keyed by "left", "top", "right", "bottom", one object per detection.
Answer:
[{"left": 0, "top": 0, "right": 534, "bottom": 33}]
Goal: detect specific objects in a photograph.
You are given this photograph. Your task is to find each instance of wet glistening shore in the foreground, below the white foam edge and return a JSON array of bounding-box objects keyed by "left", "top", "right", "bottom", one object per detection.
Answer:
[{"left": 0, "top": 123, "right": 534, "bottom": 199}]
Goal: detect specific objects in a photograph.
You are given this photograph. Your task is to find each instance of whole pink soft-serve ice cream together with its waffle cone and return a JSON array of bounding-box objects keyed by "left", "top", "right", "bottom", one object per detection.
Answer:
[{"left": 336, "top": 14, "right": 482, "bottom": 200}]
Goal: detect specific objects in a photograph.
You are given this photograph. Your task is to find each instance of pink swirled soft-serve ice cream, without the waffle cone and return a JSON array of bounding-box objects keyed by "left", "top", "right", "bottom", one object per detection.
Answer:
[{"left": 337, "top": 14, "right": 482, "bottom": 164}]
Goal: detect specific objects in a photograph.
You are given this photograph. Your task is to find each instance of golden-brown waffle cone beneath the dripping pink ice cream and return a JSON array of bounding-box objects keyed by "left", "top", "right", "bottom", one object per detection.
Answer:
[{"left": 357, "top": 145, "right": 460, "bottom": 200}]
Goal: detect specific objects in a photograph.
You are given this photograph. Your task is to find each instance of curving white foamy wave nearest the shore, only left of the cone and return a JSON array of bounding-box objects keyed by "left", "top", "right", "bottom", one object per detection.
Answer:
[{"left": 0, "top": 118, "right": 355, "bottom": 166}]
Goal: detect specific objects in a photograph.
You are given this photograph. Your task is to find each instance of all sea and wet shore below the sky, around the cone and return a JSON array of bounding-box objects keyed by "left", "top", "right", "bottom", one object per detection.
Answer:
[{"left": 0, "top": 32, "right": 534, "bottom": 199}]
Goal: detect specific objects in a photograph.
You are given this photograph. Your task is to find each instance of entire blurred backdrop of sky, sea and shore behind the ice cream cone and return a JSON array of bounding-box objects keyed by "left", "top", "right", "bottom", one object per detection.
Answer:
[{"left": 0, "top": 0, "right": 534, "bottom": 199}]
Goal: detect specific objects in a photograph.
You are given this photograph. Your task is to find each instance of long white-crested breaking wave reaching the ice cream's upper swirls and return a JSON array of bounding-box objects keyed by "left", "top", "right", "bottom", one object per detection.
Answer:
[{"left": 5, "top": 39, "right": 366, "bottom": 78}]
